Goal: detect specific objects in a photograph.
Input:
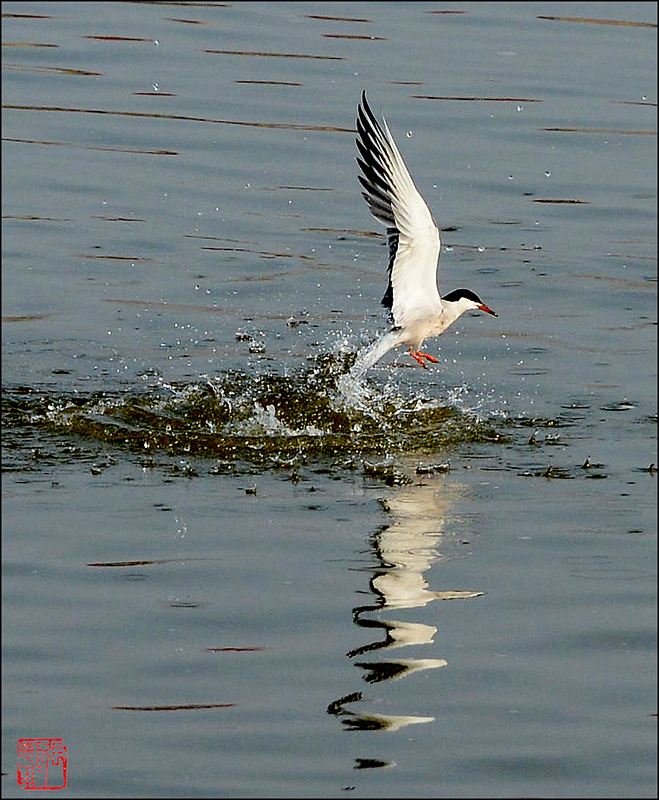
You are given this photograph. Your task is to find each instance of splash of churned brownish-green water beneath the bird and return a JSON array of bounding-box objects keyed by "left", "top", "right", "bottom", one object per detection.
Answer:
[{"left": 5, "top": 352, "right": 504, "bottom": 465}]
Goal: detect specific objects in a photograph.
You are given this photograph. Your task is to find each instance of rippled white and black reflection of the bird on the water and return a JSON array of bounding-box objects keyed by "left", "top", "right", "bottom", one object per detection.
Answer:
[{"left": 327, "top": 468, "right": 484, "bottom": 736}]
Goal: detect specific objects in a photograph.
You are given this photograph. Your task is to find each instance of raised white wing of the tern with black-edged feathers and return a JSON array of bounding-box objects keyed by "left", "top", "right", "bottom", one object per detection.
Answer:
[{"left": 356, "top": 92, "right": 441, "bottom": 327}]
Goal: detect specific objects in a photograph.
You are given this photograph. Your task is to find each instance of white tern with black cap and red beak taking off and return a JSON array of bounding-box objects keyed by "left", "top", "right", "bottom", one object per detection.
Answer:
[{"left": 351, "top": 92, "right": 497, "bottom": 376}]
